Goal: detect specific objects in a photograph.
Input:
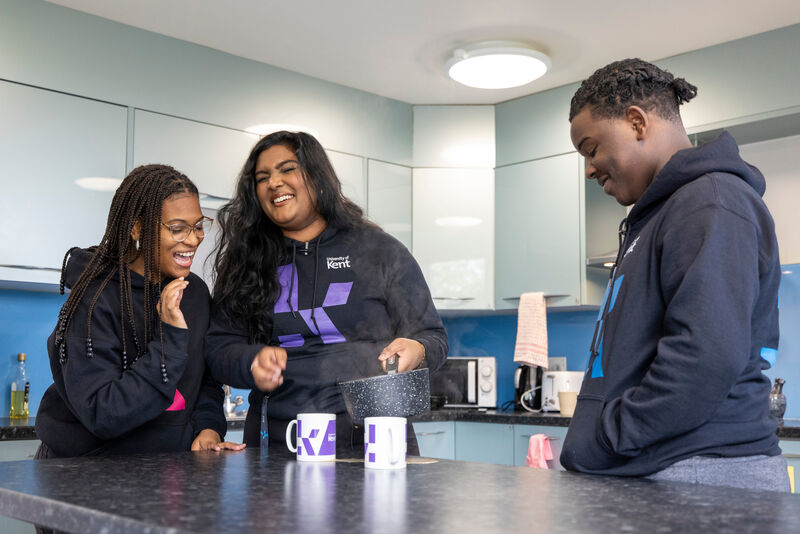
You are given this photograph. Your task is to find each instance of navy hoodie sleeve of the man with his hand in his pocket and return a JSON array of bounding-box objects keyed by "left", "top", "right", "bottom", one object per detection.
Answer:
[{"left": 586, "top": 205, "right": 762, "bottom": 465}]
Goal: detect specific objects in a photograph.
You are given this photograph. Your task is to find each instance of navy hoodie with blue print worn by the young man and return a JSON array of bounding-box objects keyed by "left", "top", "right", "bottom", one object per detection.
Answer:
[{"left": 561, "top": 133, "right": 781, "bottom": 476}]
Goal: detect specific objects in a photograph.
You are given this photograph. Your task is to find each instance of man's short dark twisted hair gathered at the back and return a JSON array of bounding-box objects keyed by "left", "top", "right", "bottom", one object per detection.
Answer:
[{"left": 569, "top": 58, "right": 697, "bottom": 122}]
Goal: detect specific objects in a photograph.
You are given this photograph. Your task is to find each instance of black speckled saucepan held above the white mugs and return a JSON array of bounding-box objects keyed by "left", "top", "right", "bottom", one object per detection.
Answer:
[{"left": 339, "top": 368, "right": 431, "bottom": 425}]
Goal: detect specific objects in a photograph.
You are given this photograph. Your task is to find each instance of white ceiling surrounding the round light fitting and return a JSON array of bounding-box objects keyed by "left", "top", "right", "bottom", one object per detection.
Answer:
[{"left": 45, "top": 0, "right": 800, "bottom": 104}]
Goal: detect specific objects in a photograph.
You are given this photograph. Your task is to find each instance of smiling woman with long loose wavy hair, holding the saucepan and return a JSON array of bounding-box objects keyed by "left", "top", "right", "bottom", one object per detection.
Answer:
[{"left": 207, "top": 131, "right": 447, "bottom": 457}]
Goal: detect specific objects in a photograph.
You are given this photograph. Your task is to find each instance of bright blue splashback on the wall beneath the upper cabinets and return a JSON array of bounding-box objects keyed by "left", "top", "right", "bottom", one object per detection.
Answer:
[{"left": 0, "top": 264, "right": 800, "bottom": 426}]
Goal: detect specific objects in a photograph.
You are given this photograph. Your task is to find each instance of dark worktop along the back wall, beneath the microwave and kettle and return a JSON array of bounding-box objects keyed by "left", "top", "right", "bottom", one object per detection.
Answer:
[{"left": 0, "top": 409, "right": 800, "bottom": 441}]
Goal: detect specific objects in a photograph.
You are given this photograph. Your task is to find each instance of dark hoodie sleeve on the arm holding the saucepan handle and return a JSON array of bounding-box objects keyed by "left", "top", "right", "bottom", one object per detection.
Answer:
[{"left": 385, "top": 242, "right": 448, "bottom": 371}]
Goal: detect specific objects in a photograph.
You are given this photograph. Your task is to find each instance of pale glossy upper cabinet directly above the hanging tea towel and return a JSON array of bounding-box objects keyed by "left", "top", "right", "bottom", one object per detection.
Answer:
[{"left": 495, "top": 153, "right": 582, "bottom": 309}]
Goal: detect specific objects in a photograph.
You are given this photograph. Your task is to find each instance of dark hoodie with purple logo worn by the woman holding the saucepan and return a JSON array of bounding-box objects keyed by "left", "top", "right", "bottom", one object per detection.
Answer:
[{"left": 207, "top": 227, "right": 447, "bottom": 446}]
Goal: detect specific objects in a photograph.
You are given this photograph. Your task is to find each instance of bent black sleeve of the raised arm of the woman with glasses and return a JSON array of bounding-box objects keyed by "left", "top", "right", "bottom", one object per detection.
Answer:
[{"left": 62, "top": 314, "right": 189, "bottom": 439}]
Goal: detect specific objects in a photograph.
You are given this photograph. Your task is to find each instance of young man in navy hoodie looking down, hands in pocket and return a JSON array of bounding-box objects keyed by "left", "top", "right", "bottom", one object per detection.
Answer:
[{"left": 561, "top": 59, "right": 789, "bottom": 491}]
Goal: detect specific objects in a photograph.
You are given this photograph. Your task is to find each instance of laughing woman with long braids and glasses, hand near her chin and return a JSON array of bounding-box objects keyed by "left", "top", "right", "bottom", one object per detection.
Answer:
[{"left": 36, "top": 165, "right": 242, "bottom": 458}]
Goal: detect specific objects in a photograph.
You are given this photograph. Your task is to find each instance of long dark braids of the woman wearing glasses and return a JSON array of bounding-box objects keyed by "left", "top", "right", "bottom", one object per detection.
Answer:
[{"left": 55, "top": 165, "right": 198, "bottom": 382}]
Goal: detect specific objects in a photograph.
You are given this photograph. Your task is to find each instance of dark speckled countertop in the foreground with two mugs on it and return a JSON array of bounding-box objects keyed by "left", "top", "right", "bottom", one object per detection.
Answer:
[{"left": 0, "top": 449, "right": 800, "bottom": 534}]
